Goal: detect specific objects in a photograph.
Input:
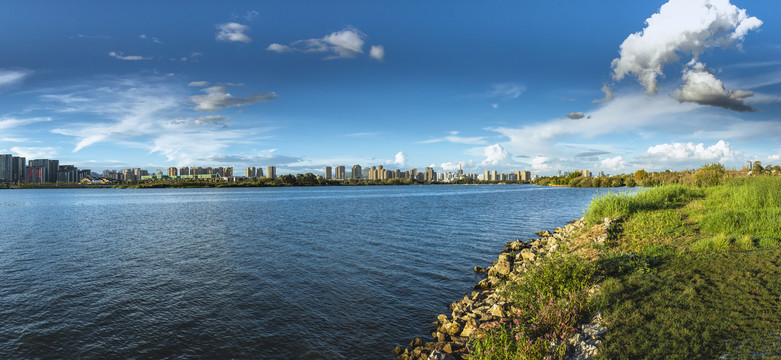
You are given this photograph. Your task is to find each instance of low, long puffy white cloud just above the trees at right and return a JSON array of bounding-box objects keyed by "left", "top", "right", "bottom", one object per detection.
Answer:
[{"left": 644, "top": 140, "right": 734, "bottom": 163}]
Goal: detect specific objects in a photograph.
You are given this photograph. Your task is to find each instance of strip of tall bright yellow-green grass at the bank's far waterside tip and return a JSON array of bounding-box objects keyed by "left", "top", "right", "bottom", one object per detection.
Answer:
[{"left": 585, "top": 185, "right": 705, "bottom": 225}]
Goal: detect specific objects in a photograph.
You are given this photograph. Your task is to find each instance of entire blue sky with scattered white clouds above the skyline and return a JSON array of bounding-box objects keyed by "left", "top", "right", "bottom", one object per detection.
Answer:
[{"left": 0, "top": 0, "right": 781, "bottom": 175}]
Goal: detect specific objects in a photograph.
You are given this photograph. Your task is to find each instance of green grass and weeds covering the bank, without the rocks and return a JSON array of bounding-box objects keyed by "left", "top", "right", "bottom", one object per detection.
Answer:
[{"left": 470, "top": 176, "right": 781, "bottom": 360}]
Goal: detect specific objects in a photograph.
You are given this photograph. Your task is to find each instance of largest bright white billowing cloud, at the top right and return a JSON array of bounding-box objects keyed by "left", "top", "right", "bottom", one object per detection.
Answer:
[{"left": 611, "top": 0, "right": 762, "bottom": 94}]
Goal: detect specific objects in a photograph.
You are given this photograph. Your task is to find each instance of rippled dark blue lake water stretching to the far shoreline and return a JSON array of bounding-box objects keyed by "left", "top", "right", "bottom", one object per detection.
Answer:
[{"left": 0, "top": 185, "right": 632, "bottom": 359}]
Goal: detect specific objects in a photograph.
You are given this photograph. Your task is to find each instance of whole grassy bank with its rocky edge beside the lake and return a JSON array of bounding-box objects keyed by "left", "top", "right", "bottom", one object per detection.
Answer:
[{"left": 394, "top": 164, "right": 781, "bottom": 360}]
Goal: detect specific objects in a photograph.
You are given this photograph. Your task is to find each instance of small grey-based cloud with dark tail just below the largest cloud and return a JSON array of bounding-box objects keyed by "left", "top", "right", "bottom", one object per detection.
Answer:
[{"left": 677, "top": 62, "right": 755, "bottom": 111}]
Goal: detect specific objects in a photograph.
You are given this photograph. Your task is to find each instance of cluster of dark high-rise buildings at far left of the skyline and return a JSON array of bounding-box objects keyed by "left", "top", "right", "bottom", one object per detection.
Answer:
[{"left": 0, "top": 154, "right": 92, "bottom": 183}]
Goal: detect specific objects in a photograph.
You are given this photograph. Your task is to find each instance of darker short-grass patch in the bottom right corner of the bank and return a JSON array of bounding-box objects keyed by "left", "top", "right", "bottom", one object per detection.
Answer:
[{"left": 593, "top": 249, "right": 781, "bottom": 359}]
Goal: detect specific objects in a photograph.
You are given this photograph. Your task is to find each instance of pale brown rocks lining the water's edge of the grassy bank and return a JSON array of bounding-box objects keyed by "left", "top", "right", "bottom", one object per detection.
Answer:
[{"left": 393, "top": 219, "right": 610, "bottom": 360}]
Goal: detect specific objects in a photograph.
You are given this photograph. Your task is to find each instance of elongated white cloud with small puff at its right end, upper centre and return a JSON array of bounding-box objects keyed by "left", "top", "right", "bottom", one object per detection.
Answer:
[{"left": 266, "top": 28, "right": 385, "bottom": 60}]
